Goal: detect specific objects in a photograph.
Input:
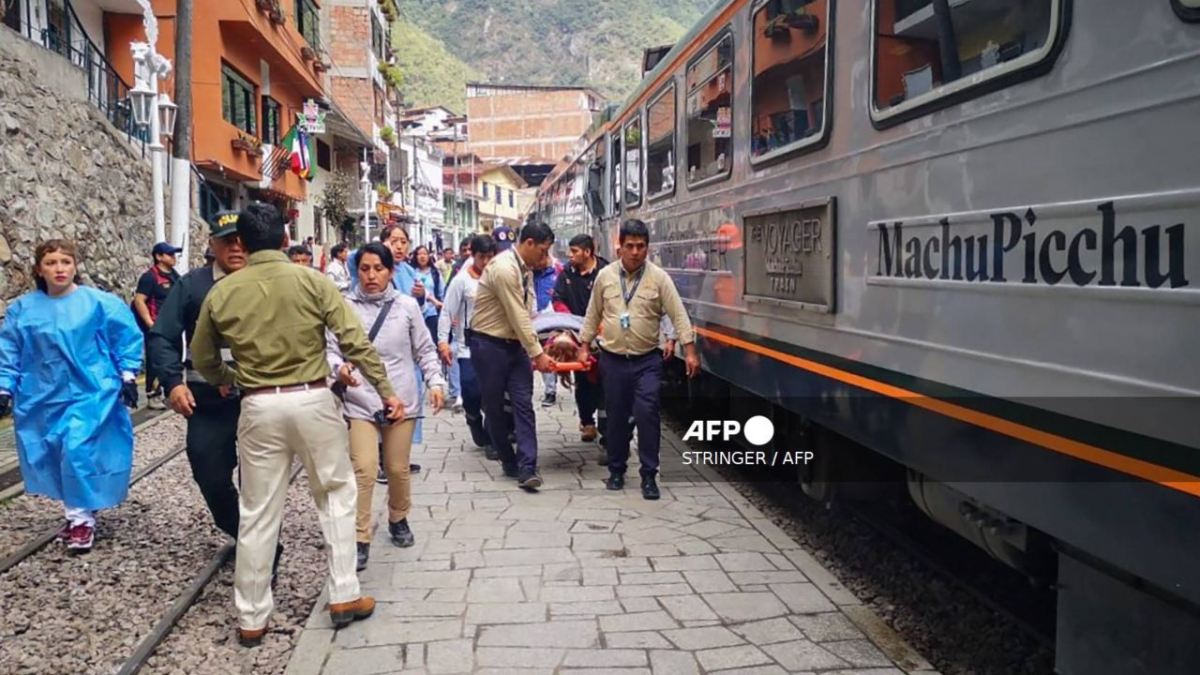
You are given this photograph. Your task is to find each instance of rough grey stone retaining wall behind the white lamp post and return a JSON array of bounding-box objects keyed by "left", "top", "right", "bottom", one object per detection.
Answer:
[{"left": 0, "top": 25, "right": 205, "bottom": 316}]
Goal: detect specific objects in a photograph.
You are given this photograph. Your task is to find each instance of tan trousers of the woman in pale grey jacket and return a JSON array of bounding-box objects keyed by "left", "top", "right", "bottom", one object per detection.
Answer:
[{"left": 350, "top": 419, "right": 416, "bottom": 544}]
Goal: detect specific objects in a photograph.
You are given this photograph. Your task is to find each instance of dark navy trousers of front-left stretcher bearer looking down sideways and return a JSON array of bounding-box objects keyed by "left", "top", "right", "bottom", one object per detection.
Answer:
[{"left": 463, "top": 334, "right": 538, "bottom": 473}]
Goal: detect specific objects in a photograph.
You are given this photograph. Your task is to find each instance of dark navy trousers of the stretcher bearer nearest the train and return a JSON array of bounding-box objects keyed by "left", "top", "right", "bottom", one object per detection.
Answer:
[{"left": 600, "top": 350, "right": 662, "bottom": 478}]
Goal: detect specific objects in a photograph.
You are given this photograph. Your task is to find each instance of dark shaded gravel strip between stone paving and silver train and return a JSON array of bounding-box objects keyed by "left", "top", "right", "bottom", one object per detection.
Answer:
[{"left": 724, "top": 471, "right": 1054, "bottom": 675}]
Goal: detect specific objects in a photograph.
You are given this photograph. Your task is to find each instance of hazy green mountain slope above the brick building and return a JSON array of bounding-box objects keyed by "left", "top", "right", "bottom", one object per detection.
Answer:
[{"left": 396, "top": 0, "right": 714, "bottom": 107}]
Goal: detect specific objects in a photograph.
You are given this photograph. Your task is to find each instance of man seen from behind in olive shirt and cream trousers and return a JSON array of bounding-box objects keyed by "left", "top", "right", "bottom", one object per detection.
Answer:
[{"left": 192, "top": 203, "right": 404, "bottom": 646}]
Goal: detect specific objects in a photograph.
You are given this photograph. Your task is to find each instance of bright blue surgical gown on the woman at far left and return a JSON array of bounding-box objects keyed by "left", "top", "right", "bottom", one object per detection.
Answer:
[{"left": 0, "top": 286, "right": 142, "bottom": 510}]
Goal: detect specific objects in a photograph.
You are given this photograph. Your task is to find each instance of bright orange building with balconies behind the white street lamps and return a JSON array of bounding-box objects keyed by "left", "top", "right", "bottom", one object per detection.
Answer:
[{"left": 104, "top": 0, "right": 328, "bottom": 213}]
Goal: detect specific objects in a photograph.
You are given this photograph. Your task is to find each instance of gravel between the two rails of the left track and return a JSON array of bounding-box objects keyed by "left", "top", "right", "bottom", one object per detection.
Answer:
[{"left": 0, "top": 417, "right": 224, "bottom": 675}]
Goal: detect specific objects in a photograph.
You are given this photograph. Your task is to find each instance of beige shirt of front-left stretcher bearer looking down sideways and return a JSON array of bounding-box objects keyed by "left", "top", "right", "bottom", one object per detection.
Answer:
[{"left": 460, "top": 243, "right": 542, "bottom": 358}]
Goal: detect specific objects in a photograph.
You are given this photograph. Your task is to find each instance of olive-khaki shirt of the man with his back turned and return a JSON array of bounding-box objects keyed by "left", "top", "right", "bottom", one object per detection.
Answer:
[{"left": 192, "top": 251, "right": 395, "bottom": 398}]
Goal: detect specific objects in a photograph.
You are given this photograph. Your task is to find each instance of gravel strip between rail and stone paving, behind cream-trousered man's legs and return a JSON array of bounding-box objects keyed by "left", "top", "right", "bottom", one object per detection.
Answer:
[{"left": 142, "top": 471, "right": 328, "bottom": 675}]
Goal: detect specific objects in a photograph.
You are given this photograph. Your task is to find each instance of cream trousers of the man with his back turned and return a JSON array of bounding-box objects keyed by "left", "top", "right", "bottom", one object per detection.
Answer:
[{"left": 233, "top": 389, "right": 359, "bottom": 631}]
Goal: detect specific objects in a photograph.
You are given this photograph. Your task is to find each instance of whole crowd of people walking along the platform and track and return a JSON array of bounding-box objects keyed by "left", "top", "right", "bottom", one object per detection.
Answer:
[{"left": 0, "top": 203, "right": 700, "bottom": 646}]
